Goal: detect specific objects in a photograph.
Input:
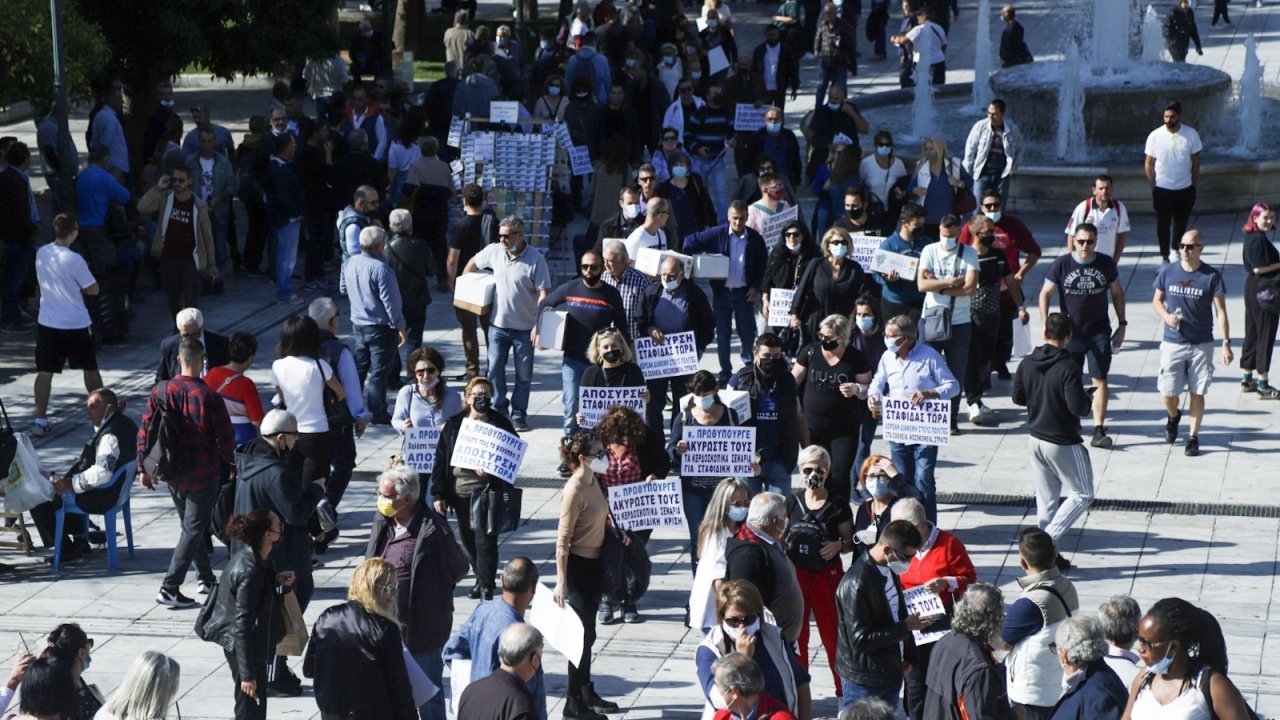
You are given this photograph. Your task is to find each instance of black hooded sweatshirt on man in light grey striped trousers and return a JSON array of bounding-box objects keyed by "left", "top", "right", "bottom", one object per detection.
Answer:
[{"left": 1014, "top": 343, "right": 1092, "bottom": 445}]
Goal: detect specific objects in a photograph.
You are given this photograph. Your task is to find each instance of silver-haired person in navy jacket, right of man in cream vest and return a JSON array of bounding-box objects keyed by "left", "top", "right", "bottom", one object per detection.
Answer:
[{"left": 1050, "top": 615, "right": 1129, "bottom": 720}]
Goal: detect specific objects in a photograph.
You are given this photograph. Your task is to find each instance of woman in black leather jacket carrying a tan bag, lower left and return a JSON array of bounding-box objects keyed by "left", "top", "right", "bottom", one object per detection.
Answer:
[{"left": 196, "top": 509, "right": 294, "bottom": 720}]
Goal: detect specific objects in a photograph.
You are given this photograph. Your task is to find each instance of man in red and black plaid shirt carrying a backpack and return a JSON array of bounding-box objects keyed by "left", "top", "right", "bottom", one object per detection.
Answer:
[{"left": 138, "top": 337, "right": 236, "bottom": 607}]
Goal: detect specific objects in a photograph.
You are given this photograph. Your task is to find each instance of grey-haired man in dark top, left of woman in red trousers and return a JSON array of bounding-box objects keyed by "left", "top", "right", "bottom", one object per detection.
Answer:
[{"left": 724, "top": 492, "right": 805, "bottom": 643}]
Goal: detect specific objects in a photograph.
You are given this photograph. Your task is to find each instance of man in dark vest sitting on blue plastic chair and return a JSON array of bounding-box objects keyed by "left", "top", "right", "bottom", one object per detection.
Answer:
[{"left": 31, "top": 388, "right": 138, "bottom": 561}]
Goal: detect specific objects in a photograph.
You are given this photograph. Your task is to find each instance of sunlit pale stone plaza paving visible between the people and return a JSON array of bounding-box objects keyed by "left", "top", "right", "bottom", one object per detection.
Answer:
[{"left": 0, "top": 3, "right": 1280, "bottom": 719}]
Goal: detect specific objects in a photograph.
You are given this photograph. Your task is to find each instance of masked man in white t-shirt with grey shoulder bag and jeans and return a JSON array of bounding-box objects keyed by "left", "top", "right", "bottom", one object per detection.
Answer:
[{"left": 915, "top": 215, "right": 972, "bottom": 430}]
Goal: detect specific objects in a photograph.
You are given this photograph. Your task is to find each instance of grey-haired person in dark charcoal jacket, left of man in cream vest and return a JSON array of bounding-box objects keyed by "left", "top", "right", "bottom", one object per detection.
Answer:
[{"left": 924, "top": 583, "right": 1012, "bottom": 720}]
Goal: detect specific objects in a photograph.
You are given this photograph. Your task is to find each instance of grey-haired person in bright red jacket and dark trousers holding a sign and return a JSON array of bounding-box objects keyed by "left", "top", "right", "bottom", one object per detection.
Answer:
[{"left": 890, "top": 498, "right": 978, "bottom": 720}]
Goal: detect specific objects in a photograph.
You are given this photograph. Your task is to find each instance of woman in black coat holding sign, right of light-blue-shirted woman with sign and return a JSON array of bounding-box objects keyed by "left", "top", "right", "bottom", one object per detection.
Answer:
[{"left": 430, "top": 377, "right": 517, "bottom": 600}]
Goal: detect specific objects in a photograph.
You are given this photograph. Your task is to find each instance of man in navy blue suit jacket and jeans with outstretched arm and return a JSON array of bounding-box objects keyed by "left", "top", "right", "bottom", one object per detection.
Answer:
[{"left": 684, "top": 200, "right": 768, "bottom": 387}]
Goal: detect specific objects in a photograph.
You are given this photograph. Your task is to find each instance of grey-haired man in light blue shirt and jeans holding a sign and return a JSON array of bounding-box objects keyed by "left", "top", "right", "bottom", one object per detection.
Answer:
[{"left": 867, "top": 315, "right": 960, "bottom": 523}]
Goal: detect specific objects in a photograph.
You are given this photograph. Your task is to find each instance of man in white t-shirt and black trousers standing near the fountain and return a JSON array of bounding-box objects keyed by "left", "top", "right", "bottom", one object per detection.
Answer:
[{"left": 1146, "top": 100, "right": 1204, "bottom": 263}]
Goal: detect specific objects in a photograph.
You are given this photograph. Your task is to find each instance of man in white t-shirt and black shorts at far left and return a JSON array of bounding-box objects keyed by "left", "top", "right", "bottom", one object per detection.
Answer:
[{"left": 36, "top": 213, "right": 102, "bottom": 434}]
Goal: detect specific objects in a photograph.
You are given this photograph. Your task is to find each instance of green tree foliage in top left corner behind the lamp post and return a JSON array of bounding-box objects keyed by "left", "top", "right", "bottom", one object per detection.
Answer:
[{"left": 0, "top": 0, "right": 110, "bottom": 108}]
